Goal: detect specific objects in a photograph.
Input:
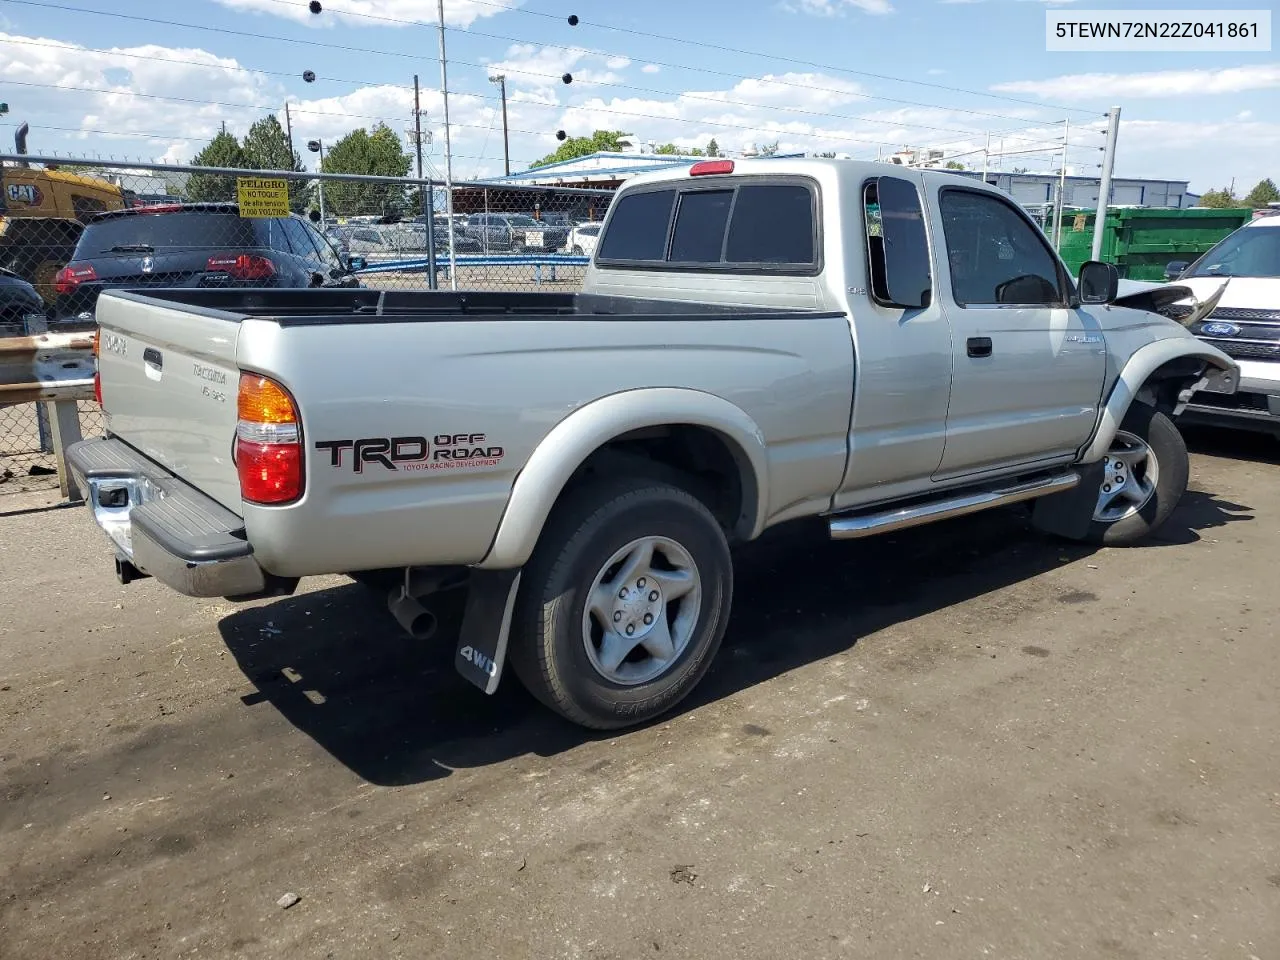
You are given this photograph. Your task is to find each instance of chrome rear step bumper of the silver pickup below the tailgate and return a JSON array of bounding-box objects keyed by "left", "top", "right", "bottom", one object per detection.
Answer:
[{"left": 67, "top": 438, "right": 280, "bottom": 598}]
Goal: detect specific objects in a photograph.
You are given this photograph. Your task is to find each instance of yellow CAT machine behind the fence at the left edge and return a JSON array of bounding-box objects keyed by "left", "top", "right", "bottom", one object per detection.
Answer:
[{"left": 0, "top": 123, "right": 127, "bottom": 303}]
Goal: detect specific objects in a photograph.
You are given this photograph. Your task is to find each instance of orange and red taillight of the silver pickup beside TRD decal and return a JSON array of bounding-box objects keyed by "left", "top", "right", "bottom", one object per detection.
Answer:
[{"left": 236, "top": 374, "right": 303, "bottom": 504}]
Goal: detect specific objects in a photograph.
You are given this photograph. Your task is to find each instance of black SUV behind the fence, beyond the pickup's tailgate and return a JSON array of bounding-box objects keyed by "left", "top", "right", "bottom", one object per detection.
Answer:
[{"left": 52, "top": 204, "right": 364, "bottom": 320}]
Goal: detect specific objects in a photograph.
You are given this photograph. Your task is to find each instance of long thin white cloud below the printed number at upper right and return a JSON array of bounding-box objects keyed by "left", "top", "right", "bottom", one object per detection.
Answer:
[{"left": 992, "top": 64, "right": 1280, "bottom": 100}]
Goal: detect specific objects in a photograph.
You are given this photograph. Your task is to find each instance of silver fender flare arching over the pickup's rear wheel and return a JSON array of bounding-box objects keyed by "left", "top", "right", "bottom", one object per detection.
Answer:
[{"left": 476, "top": 387, "right": 769, "bottom": 570}]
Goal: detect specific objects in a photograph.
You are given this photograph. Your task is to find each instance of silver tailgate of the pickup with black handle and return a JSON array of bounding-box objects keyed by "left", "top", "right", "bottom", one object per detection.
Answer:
[{"left": 97, "top": 291, "right": 241, "bottom": 513}]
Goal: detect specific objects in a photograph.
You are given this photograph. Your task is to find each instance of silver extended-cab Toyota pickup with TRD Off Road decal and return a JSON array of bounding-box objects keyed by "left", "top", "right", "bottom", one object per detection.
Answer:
[{"left": 68, "top": 159, "right": 1238, "bottom": 728}]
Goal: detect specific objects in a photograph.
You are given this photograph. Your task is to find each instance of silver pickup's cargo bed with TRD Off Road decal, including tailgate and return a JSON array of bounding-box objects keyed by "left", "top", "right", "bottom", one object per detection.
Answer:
[{"left": 97, "top": 289, "right": 855, "bottom": 577}]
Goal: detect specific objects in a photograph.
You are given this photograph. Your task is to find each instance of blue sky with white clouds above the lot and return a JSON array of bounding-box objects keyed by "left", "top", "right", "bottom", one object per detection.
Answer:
[{"left": 0, "top": 0, "right": 1280, "bottom": 195}]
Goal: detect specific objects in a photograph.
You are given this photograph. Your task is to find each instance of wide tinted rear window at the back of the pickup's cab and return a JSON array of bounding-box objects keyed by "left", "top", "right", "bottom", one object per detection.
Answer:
[{"left": 596, "top": 177, "right": 820, "bottom": 275}]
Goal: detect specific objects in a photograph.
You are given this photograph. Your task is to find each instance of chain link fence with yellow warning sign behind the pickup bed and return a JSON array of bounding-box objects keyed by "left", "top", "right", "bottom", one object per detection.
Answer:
[{"left": 0, "top": 155, "right": 612, "bottom": 493}]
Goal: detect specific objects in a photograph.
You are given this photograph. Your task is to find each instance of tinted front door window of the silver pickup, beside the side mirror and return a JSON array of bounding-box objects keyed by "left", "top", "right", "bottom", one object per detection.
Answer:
[{"left": 940, "top": 189, "right": 1068, "bottom": 307}]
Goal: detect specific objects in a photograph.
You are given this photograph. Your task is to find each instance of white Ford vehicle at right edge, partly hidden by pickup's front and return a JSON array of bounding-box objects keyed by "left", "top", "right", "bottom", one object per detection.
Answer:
[{"left": 1165, "top": 212, "right": 1280, "bottom": 436}]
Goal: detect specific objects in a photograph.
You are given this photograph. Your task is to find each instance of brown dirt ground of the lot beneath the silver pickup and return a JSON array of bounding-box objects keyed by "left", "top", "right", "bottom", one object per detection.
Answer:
[{"left": 0, "top": 435, "right": 1280, "bottom": 960}]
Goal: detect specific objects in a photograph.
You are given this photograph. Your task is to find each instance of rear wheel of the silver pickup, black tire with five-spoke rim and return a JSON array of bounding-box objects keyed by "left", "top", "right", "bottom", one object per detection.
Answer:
[{"left": 508, "top": 479, "right": 733, "bottom": 730}]
